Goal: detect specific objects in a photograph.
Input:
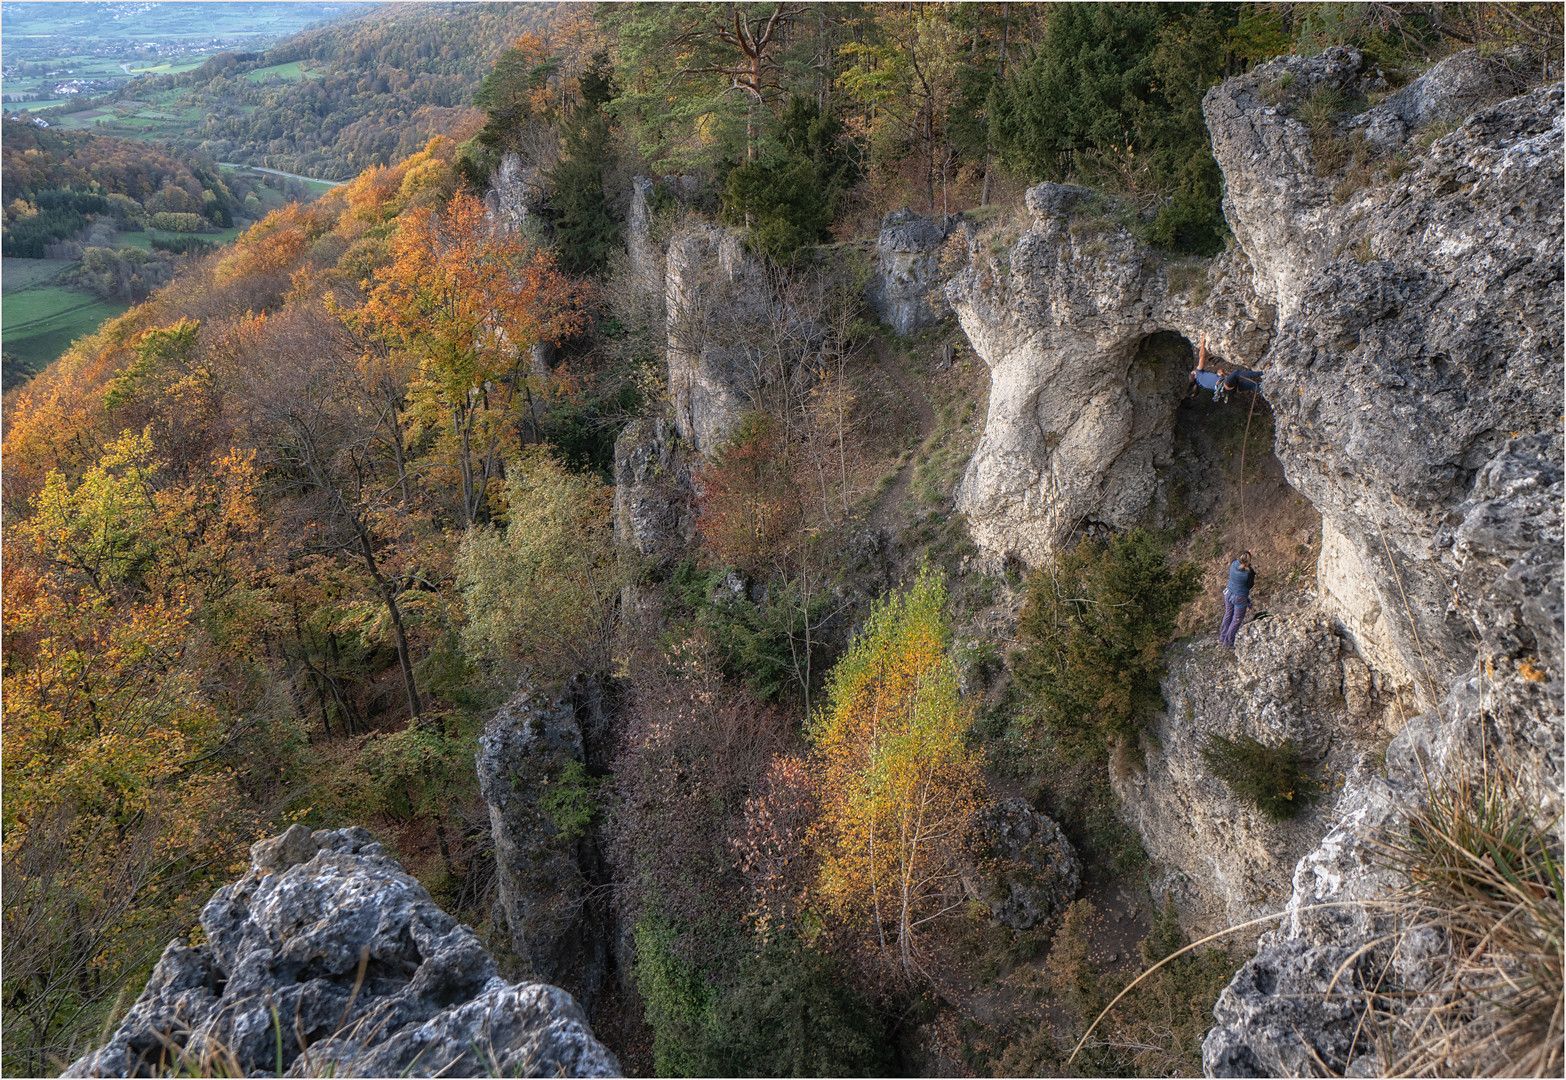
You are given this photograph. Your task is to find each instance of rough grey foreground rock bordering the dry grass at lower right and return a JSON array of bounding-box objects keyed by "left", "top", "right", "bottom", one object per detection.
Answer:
[{"left": 1203, "top": 432, "right": 1566, "bottom": 1077}]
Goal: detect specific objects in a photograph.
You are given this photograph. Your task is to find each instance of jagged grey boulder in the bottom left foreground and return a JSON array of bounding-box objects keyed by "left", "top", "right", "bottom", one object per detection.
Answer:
[{"left": 64, "top": 825, "right": 620, "bottom": 1077}]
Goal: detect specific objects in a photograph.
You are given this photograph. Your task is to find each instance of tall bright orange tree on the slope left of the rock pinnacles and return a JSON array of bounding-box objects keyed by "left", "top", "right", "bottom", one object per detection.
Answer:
[{"left": 346, "top": 194, "right": 589, "bottom": 524}]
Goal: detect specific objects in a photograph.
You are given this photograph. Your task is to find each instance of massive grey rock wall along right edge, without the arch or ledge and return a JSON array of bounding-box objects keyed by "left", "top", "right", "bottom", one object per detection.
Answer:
[{"left": 1183, "top": 50, "right": 1566, "bottom": 1075}]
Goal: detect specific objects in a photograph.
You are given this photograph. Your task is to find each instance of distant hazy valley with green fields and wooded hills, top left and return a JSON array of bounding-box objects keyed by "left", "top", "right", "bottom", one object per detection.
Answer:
[{"left": 0, "top": 2, "right": 553, "bottom": 388}]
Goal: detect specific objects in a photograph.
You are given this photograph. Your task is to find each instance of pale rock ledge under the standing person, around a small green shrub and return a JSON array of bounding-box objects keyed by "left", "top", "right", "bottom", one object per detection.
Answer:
[{"left": 1110, "top": 606, "right": 1400, "bottom": 933}]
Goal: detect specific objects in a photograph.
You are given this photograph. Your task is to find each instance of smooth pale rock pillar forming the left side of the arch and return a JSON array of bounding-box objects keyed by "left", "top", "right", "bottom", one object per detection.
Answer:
[{"left": 946, "top": 183, "right": 1272, "bottom": 565}]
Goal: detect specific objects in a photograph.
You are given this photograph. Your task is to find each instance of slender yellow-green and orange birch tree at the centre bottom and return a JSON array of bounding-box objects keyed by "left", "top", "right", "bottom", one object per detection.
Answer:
[{"left": 810, "top": 568, "right": 983, "bottom": 975}]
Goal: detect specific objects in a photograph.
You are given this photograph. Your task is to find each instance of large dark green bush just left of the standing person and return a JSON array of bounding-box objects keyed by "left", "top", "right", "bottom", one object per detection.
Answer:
[{"left": 1012, "top": 529, "right": 1200, "bottom": 753}]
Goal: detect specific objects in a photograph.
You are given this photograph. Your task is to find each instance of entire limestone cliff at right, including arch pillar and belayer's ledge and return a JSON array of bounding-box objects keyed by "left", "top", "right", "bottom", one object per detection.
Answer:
[{"left": 947, "top": 49, "right": 1563, "bottom": 1075}]
